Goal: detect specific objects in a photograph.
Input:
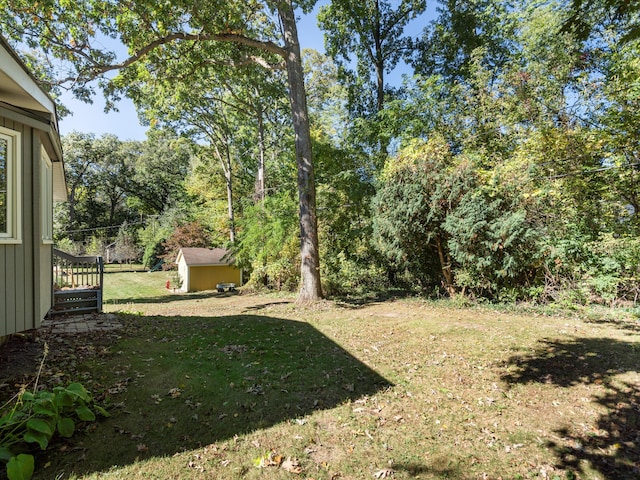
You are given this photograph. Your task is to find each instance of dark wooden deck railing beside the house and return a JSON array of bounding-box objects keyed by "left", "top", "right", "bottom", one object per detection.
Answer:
[{"left": 53, "top": 248, "right": 104, "bottom": 313}]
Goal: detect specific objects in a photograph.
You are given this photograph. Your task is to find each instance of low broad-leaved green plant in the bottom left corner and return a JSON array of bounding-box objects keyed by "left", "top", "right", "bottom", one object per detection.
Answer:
[{"left": 0, "top": 344, "right": 109, "bottom": 480}]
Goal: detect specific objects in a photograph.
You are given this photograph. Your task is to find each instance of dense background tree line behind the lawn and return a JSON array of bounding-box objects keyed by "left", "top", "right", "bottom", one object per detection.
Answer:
[{"left": 3, "top": 0, "right": 640, "bottom": 303}]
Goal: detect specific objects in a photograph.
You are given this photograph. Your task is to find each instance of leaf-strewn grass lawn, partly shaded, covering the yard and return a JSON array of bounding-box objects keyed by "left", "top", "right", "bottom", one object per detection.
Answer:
[{"left": 8, "top": 272, "right": 640, "bottom": 480}]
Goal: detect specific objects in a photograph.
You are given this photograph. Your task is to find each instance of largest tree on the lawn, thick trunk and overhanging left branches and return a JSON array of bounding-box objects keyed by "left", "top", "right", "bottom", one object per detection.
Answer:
[{"left": 0, "top": 0, "right": 322, "bottom": 301}]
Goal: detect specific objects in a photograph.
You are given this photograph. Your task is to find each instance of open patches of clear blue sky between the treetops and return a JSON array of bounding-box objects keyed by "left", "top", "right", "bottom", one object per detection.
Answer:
[{"left": 60, "top": 1, "right": 425, "bottom": 140}]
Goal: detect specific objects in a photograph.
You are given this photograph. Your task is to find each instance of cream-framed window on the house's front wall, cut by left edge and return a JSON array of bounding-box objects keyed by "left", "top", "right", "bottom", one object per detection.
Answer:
[{"left": 0, "top": 127, "right": 21, "bottom": 243}]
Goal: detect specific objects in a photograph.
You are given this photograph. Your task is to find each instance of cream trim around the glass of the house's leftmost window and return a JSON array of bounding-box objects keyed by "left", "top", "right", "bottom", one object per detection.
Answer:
[{"left": 0, "top": 127, "right": 22, "bottom": 244}]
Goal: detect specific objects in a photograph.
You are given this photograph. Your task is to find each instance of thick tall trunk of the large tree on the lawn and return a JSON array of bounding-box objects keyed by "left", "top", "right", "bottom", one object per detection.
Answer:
[{"left": 278, "top": 0, "right": 322, "bottom": 302}]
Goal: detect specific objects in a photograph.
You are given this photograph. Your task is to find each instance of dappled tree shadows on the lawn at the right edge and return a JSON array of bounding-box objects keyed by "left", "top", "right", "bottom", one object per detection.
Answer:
[{"left": 502, "top": 338, "right": 640, "bottom": 480}]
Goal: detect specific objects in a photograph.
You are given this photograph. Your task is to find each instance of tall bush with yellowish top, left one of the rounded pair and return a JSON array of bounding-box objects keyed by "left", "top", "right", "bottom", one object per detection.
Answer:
[{"left": 372, "top": 137, "right": 464, "bottom": 293}]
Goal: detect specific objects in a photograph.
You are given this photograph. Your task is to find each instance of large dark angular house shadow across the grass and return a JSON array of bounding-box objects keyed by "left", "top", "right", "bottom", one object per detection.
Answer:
[{"left": 37, "top": 315, "right": 392, "bottom": 478}]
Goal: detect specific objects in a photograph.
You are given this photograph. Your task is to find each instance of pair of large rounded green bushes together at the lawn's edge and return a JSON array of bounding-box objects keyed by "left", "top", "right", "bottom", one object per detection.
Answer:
[{"left": 373, "top": 137, "right": 542, "bottom": 302}]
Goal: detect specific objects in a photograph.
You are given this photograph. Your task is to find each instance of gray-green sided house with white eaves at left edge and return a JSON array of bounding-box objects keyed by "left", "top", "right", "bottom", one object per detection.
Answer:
[{"left": 0, "top": 36, "right": 67, "bottom": 338}]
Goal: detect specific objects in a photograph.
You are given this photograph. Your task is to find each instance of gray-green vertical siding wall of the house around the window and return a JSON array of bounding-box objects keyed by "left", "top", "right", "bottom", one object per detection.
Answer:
[{"left": 0, "top": 117, "right": 52, "bottom": 337}]
